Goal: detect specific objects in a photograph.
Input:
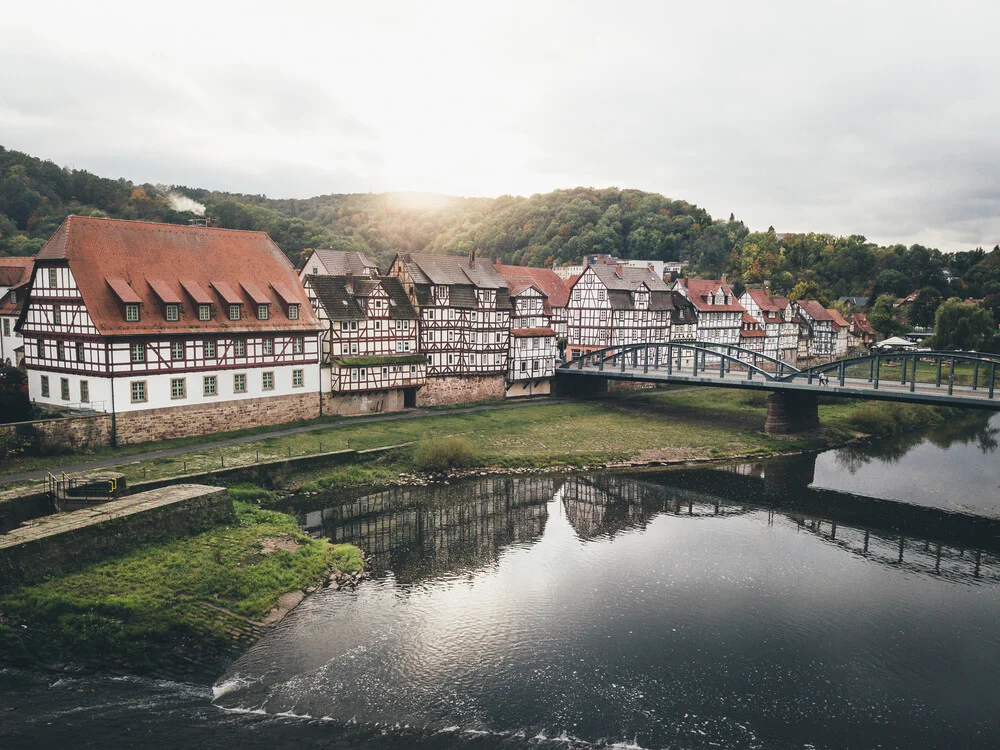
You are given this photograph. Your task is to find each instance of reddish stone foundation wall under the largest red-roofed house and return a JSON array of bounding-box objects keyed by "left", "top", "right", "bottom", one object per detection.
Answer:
[{"left": 116, "top": 393, "right": 319, "bottom": 445}]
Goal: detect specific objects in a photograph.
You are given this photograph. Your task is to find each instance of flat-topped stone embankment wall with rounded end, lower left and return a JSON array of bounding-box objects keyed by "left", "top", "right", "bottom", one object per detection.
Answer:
[{"left": 0, "top": 484, "right": 233, "bottom": 588}]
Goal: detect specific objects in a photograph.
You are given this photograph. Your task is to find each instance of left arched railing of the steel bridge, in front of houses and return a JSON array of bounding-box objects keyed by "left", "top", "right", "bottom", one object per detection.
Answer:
[{"left": 560, "top": 341, "right": 799, "bottom": 380}]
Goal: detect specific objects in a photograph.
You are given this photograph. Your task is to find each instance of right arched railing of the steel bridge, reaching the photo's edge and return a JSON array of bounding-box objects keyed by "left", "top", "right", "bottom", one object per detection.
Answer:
[{"left": 784, "top": 350, "right": 1000, "bottom": 399}]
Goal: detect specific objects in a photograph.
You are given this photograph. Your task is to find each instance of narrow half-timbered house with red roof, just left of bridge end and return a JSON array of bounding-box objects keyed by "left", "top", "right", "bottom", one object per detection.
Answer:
[{"left": 496, "top": 263, "right": 559, "bottom": 398}]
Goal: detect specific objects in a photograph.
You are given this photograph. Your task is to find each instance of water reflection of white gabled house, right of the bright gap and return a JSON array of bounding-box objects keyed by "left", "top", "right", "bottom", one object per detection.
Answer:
[{"left": 561, "top": 475, "right": 749, "bottom": 539}]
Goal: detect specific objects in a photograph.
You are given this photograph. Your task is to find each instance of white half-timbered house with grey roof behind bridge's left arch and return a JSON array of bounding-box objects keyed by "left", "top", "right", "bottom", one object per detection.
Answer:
[{"left": 566, "top": 264, "right": 693, "bottom": 359}]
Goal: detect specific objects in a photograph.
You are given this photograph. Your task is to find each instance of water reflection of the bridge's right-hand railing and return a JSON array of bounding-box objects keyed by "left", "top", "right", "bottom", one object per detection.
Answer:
[{"left": 787, "top": 514, "right": 1000, "bottom": 582}]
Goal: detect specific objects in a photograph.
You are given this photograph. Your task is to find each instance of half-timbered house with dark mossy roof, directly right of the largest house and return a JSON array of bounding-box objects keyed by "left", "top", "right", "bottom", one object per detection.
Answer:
[{"left": 300, "top": 250, "right": 427, "bottom": 414}]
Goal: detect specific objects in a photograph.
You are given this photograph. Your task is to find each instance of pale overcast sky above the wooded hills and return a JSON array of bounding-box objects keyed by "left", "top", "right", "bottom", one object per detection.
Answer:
[{"left": 0, "top": 0, "right": 1000, "bottom": 250}]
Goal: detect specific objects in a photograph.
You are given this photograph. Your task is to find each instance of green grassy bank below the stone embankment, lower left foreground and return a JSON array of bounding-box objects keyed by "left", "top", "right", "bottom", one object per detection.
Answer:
[{"left": 0, "top": 501, "right": 361, "bottom": 677}]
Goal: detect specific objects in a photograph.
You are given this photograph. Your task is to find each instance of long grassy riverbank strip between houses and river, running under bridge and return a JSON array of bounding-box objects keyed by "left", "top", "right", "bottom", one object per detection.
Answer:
[{"left": 4, "top": 388, "right": 968, "bottom": 496}]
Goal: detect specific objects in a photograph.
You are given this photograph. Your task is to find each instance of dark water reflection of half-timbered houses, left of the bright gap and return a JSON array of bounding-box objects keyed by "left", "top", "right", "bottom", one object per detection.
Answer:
[{"left": 301, "top": 477, "right": 562, "bottom": 580}]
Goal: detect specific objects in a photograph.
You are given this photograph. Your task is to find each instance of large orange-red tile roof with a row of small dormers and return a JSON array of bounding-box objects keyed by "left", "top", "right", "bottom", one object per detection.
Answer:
[{"left": 37, "top": 216, "right": 320, "bottom": 335}]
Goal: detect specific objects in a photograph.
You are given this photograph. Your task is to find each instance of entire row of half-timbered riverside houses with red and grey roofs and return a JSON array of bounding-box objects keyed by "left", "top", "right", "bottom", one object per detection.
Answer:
[{"left": 7, "top": 216, "right": 868, "bottom": 443}]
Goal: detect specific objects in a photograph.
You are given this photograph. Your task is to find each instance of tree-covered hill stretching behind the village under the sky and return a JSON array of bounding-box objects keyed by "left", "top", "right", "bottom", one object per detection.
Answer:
[{"left": 0, "top": 146, "right": 1000, "bottom": 298}]
